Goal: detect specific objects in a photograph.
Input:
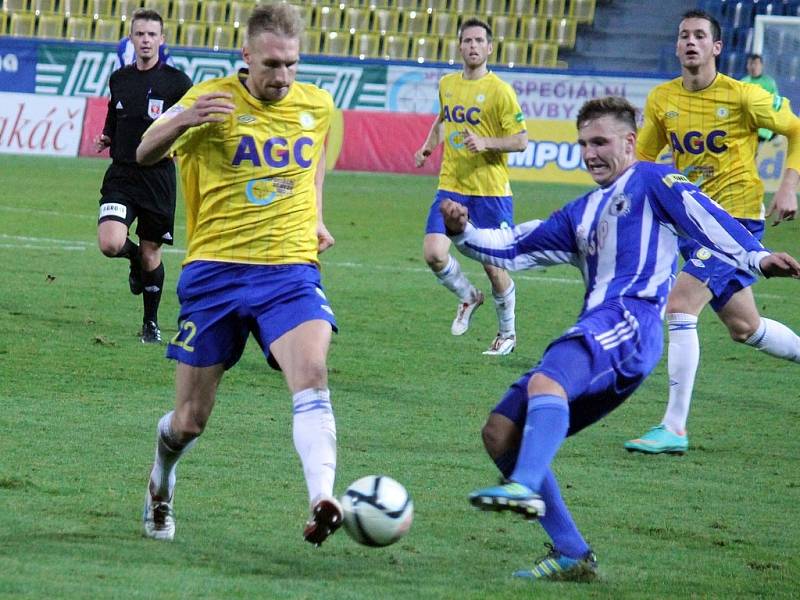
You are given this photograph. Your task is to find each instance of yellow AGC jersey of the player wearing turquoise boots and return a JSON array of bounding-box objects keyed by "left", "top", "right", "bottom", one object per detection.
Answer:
[{"left": 636, "top": 73, "right": 800, "bottom": 220}]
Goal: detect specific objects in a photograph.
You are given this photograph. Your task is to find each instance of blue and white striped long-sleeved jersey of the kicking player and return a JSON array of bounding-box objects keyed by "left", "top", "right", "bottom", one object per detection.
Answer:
[{"left": 453, "top": 162, "right": 769, "bottom": 315}]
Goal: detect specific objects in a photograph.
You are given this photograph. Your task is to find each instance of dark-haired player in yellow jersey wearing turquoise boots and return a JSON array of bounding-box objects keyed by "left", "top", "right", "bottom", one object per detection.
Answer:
[{"left": 625, "top": 10, "right": 800, "bottom": 454}]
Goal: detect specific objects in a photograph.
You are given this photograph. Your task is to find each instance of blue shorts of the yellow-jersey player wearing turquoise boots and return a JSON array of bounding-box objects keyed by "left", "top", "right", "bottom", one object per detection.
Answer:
[{"left": 678, "top": 219, "right": 764, "bottom": 312}]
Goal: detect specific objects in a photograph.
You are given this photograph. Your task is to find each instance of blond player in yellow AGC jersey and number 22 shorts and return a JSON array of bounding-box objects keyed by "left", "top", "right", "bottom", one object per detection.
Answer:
[{"left": 132, "top": 4, "right": 342, "bottom": 545}]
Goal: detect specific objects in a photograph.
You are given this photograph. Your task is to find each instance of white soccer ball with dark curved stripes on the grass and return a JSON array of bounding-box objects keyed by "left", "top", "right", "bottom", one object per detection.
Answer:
[{"left": 342, "top": 475, "right": 414, "bottom": 546}]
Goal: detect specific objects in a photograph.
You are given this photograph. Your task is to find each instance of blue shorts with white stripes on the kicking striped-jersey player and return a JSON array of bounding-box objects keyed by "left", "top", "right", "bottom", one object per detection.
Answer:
[{"left": 492, "top": 299, "right": 664, "bottom": 435}]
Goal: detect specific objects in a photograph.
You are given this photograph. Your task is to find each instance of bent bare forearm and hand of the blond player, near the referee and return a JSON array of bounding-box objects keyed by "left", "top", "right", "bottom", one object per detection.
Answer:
[{"left": 136, "top": 92, "right": 235, "bottom": 165}]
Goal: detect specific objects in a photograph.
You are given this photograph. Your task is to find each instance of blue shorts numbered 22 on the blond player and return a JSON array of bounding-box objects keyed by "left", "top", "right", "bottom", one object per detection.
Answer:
[{"left": 167, "top": 261, "right": 337, "bottom": 369}]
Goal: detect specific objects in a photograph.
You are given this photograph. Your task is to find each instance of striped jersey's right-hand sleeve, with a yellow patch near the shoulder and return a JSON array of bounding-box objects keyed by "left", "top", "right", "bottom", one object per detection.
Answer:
[{"left": 648, "top": 171, "right": 769, "bottom": 275}]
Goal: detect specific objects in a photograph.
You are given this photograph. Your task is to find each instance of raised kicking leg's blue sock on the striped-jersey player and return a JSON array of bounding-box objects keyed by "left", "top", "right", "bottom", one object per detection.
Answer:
[{"left": 511, "top": 394, "right": 569, "bottom": 492}]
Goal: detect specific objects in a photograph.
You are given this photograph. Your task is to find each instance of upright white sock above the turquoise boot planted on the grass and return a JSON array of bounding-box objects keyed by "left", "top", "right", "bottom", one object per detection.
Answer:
[{"left": 661, "top": 313, "right": 700, "bottom": 435}]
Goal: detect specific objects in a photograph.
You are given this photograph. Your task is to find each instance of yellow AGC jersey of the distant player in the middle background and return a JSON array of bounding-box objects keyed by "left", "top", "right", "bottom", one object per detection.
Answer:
[{"left": 439, "top": 72, "right": 525, "bottom": 196}]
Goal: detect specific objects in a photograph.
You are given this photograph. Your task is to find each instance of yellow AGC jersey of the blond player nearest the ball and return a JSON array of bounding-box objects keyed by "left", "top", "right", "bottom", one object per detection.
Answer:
[{"left": 145, "top": 70, "right": 334, "bottom": 264}]
